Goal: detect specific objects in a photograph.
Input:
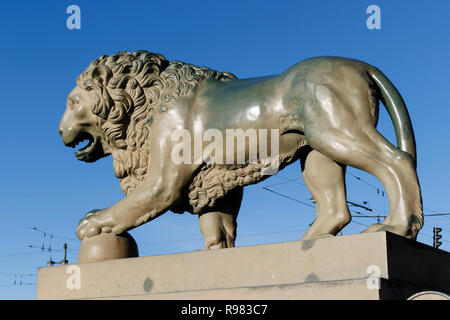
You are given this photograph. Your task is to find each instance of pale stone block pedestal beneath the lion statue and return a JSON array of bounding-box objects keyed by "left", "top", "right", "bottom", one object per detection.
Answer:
[{"left": 37, "top": 232, "right": 450, "bottom": 300}]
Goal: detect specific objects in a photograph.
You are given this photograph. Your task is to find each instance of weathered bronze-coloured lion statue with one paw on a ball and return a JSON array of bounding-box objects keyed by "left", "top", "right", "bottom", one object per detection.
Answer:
[{"left": 59, "top": 51, "right": 423, "bottom": 249}]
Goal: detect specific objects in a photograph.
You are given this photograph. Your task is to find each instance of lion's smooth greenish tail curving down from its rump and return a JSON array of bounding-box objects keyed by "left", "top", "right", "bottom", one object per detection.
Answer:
[{"left": 369, "top": 68, "right": 417, "bottom": 165}]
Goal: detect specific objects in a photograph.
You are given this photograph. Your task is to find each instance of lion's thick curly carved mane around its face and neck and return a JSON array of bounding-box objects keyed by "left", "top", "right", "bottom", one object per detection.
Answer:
[{"left": 77, "top": 51, "right": 250, "bottom": 207}]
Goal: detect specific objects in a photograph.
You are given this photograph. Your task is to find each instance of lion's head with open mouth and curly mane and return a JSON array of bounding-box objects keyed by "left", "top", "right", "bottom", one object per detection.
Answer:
[{"left": 59, "top": 51, "right": 235, "bottom": 195}]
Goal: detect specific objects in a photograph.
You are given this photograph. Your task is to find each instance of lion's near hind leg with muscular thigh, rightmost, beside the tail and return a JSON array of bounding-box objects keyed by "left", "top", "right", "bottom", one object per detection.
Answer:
[{"left": 304, "top": 82, "right": 423, "bottom": 239}]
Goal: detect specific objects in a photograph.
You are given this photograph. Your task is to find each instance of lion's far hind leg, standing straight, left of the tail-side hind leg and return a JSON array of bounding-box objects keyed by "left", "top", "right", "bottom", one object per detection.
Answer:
[{"left": 301, "top": 150, "right": 351, "bottom": 240}]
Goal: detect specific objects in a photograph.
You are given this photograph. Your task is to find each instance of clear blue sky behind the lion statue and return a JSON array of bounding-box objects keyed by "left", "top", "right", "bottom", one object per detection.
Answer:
[{"left": 0, "top": 0, "right": 450, "bottom": 299}]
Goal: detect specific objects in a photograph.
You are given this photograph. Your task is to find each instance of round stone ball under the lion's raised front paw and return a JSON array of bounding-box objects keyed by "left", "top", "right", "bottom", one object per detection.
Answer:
[{"left": 78, "top": 232, "right": 139, "bottom": 263}]
